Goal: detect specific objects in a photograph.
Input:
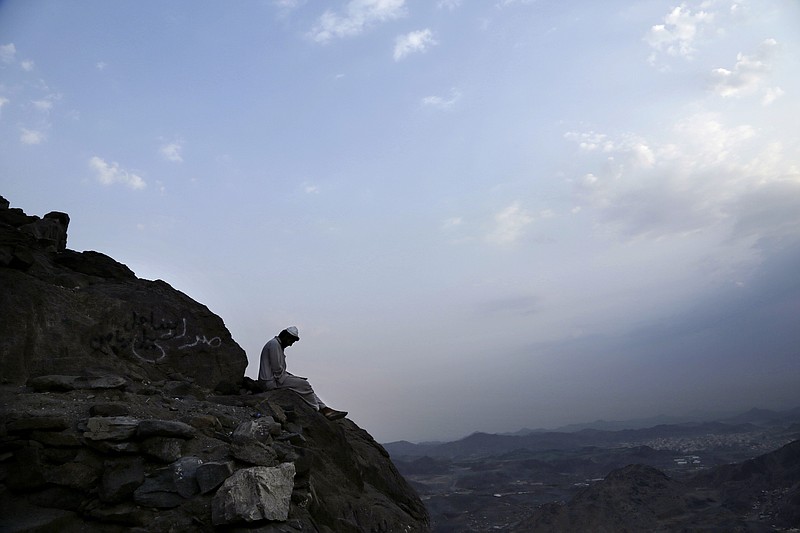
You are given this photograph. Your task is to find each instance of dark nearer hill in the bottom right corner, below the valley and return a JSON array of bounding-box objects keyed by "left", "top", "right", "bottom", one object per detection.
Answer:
[{"left": 503, "top": 441, "right": 800, "bottom": 533}]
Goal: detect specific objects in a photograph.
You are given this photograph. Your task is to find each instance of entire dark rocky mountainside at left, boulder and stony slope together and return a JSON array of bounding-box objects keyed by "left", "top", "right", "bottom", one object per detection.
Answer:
[{"left": 0, "top": 198, "right": 428, "bottom": 532}]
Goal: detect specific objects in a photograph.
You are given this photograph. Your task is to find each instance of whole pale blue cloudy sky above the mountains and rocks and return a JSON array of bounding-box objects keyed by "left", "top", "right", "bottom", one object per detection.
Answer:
[{"left": 0, "top": 0, "right": 800, "bottom": 442}]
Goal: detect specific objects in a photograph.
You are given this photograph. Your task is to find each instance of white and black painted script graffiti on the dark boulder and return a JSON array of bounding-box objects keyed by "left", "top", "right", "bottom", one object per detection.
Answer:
[{"left": 91, "top": 311, "right": 222, "bottom": 363}]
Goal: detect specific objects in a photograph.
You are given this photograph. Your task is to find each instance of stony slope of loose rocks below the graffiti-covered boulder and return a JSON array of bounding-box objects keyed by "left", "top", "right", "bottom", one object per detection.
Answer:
[{"left": 0, "top": 375, "right": 427, "bottom": 532}]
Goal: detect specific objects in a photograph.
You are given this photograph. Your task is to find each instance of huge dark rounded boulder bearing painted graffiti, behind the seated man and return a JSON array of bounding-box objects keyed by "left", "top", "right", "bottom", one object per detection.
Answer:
[{"left": 0, "top": 195, "right": 247, "bottom": 390}]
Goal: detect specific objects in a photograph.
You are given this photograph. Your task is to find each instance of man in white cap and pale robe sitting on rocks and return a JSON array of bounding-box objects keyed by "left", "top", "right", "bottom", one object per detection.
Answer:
[{"left": 258, "top": 326, "right": 347, "bottom": 420}]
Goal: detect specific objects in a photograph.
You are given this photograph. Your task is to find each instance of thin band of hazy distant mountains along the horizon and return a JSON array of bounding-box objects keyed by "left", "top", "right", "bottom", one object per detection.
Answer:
[{"left": 383, "top": 408, "right": 800, "bottom": 458}]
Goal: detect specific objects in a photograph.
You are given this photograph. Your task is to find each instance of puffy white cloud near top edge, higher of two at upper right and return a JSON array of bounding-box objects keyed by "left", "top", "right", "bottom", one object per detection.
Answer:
[{"left": 645, "top": 3, "right": 714, "bottom": 62}]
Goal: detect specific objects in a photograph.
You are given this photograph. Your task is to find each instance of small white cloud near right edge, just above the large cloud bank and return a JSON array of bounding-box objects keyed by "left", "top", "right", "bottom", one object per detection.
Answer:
[{"left": 711, "top": 39, "right": 779, "bottom": 103}]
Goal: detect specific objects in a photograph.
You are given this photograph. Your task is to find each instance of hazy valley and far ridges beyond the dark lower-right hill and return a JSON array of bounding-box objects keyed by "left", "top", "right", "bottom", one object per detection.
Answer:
[{"left": 385, "top": 411, "right": 800, "bottom": 533}]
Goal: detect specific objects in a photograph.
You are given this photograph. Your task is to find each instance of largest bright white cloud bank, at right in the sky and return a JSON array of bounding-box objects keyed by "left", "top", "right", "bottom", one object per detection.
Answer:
[{"left": 567, "top": 113, "right": 797, "bottom": 237}]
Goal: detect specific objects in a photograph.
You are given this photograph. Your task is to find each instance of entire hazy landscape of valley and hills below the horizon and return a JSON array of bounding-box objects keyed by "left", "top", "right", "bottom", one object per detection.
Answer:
[{"left": 384, "top": 408, "right": 800, "bottom": 533}]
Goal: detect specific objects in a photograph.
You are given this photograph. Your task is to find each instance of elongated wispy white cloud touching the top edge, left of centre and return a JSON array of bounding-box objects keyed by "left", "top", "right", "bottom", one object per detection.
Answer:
[{"left": 308, "top": 0, "right": 406, "bottom": 43}]
